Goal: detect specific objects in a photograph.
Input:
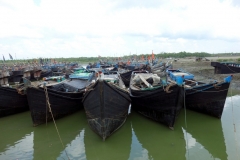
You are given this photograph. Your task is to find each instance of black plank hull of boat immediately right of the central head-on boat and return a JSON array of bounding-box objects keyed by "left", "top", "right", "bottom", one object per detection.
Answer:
[{"left": 130, "top": 85, "right": 184, "bottom": 128}]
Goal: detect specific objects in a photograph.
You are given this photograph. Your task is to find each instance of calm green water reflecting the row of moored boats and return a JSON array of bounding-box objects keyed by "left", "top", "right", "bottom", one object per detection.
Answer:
[{"left": 0, "top": 95, "right": 240, "bottom": 160}]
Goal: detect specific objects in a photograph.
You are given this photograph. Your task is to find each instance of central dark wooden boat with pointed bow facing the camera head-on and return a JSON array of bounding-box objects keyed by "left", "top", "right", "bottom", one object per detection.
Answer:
[{"left": 83, "top": 74, "right": 131, "bottom": 140}]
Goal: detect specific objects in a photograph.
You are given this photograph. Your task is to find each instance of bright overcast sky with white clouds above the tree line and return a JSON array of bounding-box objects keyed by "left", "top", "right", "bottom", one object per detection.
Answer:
[{"left": 0, "top": 0, "right": 240, "bottom": 59}]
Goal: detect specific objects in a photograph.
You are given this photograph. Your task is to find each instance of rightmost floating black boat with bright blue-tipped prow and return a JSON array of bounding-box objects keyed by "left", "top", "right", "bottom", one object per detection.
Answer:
[{"left": 185, "top": 76, "right": 231, "bottom": 118}]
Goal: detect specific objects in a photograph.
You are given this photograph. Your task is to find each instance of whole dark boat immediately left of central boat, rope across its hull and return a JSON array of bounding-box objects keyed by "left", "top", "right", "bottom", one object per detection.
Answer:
[{"left": 27, "top": 80, "right": 89, "bottom": 126}]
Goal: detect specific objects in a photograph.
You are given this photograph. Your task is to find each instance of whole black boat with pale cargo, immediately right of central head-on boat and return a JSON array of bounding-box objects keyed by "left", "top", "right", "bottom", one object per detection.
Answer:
[{"left": 129, "top": 72, "right": 184, "bottom": 129}]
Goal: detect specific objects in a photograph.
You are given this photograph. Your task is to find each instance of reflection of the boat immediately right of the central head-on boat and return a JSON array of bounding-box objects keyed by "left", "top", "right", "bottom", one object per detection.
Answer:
[{"left": 130, "top": 112, "right": 186, "bottom": 160}]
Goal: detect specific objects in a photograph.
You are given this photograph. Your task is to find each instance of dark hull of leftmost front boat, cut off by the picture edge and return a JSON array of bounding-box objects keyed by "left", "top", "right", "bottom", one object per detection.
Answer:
[{"left": 0, "top": 87, "right": 29, "bottom": 117}]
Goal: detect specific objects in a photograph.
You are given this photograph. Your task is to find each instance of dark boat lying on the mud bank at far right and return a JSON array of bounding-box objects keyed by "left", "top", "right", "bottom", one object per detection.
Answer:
[{"left": 211, "top": 62, "right": 240, "bottom": 74}]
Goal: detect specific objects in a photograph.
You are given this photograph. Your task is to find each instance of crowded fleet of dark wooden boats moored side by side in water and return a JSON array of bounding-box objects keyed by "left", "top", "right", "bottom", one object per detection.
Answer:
[{"left": 0, "top": 59, "right": 232, "bottom": 140}]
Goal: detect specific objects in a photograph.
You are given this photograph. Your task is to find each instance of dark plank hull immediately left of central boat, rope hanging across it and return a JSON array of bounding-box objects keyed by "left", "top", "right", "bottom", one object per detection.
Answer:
[{"left": 27, "top": 87, "right": 83, "bottom": 126}]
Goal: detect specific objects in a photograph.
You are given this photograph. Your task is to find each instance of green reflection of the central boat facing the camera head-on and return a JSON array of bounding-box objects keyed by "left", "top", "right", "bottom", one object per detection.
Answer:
[{"left": 84, "top": 112, "right": 132, "bottom": 160}]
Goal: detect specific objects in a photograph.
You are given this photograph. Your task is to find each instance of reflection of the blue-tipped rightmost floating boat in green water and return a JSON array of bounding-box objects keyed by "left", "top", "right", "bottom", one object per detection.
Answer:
[{"left": 183, "top": 110, "right": 228, "bottom": 160}]
